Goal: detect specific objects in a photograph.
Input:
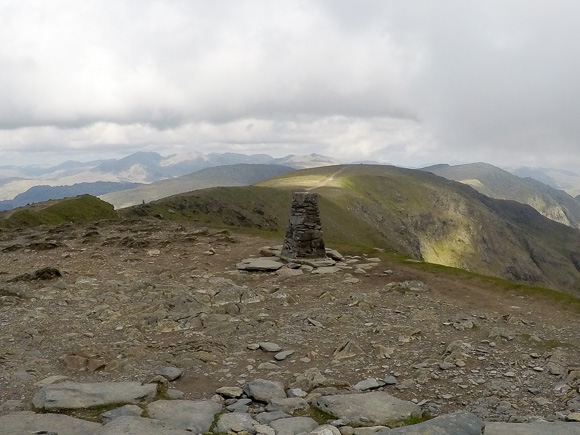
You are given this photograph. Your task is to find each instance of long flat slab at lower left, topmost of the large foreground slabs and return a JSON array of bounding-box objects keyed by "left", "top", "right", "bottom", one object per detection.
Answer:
[{"left": 32, "top": 382, "right": 157, "bottom": 411}]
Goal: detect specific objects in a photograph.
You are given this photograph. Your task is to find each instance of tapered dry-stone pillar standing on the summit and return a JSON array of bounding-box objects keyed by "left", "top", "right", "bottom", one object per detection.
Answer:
[{"left": 280, "top": 192, "right": 326, "bottom": 260}]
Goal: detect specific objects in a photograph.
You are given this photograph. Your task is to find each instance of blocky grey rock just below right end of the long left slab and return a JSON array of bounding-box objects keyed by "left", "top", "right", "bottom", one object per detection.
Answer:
[{"left": 147, "top": 400, "right": 222, "bottom": 434}]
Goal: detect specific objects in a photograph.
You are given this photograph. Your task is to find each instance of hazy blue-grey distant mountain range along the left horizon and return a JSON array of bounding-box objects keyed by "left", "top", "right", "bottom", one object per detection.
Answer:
[{"left": 0, "top": 152, "right": 338, "bottom": 209}]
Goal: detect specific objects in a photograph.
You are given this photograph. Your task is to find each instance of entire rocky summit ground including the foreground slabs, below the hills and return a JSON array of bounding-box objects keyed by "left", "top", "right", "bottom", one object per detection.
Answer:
[{"left": 0, "top": 220, "right": 580, "bottom": 435}]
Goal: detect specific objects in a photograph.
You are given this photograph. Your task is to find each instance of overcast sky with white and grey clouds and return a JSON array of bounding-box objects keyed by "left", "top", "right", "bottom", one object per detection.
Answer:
[{"left": 0, "top": 0, "right": 580, "bottom": 172}]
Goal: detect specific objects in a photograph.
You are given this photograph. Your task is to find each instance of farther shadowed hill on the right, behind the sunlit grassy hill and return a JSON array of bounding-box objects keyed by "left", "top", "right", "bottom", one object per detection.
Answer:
[{"left": 423, "top": 163, "right": 580, "bottom": 228}]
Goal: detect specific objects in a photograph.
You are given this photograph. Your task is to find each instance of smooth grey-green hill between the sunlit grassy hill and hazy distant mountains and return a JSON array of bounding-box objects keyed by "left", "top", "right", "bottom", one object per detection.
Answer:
[{"left": 100, "top": 164, "right": 293, "bottom": 208}]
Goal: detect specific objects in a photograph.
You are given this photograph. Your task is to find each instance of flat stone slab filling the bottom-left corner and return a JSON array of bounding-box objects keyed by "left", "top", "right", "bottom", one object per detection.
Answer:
[{"left": 0, "top": 411, "right": 101, "bottom": 435}]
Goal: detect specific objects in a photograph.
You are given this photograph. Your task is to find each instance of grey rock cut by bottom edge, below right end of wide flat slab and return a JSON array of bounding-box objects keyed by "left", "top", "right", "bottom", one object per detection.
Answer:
[{"left": 388, "top": 411, "right": 482, "bottom": 435}]
